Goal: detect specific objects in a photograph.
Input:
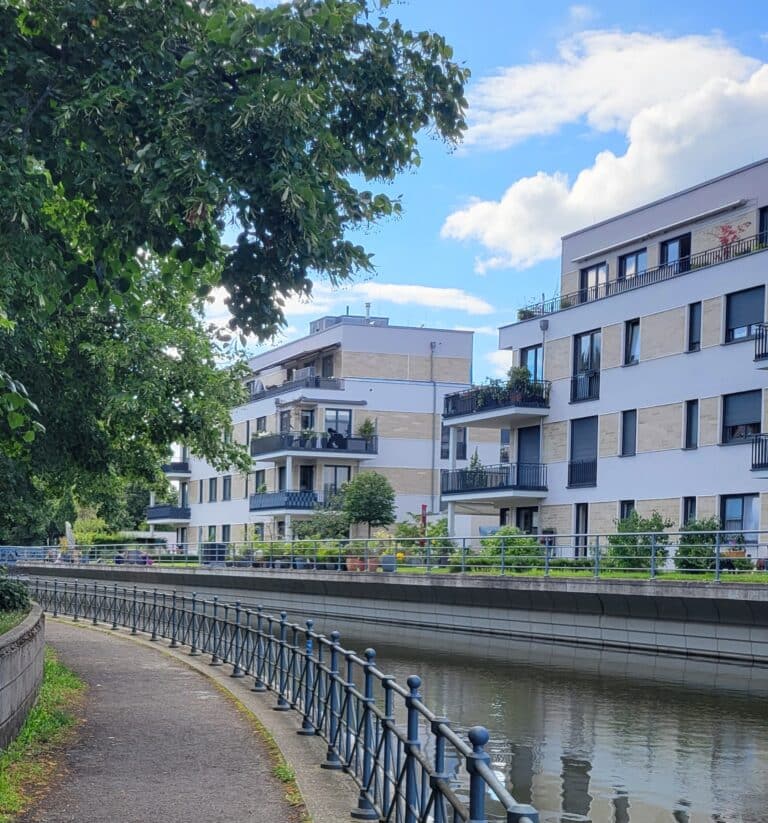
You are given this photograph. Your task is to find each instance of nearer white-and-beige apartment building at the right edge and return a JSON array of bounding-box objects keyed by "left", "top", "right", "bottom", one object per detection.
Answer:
[{"left": 442, "top": 160, "right": 768, "bottom": 540}]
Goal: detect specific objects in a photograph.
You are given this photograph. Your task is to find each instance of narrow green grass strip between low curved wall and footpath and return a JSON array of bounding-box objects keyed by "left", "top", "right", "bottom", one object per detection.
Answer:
[{"left": 0, "top": 647, "right": 85, "bottom": 823}]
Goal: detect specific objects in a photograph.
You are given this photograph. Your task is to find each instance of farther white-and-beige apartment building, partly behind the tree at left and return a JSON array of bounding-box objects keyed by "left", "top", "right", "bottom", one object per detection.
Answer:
[{"left": 148, "top": 314, "right": 495, "bottom": 544}]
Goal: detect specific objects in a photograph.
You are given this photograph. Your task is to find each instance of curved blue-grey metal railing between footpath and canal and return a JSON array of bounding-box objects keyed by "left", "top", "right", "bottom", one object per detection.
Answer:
[{"left": 27, "top": 577, "right": 539, "bottom": 823}]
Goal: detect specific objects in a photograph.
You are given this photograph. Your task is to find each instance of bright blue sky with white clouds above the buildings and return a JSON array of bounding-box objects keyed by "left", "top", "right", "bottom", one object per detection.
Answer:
[{"left": 211, "top": 0, "right": 768, "bottom": 382}]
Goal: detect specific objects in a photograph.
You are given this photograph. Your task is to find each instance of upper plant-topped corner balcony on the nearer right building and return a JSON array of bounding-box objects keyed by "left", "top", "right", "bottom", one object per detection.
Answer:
[{"left": 443, "top": 380, "right": 551, "bottom": 426}]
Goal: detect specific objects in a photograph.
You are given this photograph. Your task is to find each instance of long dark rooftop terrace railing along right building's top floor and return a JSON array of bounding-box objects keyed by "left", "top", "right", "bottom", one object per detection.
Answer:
[{"left": 517, "top": 234, "right": 768, "bottom": 321}]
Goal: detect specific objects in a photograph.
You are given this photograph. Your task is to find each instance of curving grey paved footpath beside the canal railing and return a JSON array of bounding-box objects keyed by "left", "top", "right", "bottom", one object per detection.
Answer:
[{"left": 19, "top": 620, "right": 299, "bottom": 823}]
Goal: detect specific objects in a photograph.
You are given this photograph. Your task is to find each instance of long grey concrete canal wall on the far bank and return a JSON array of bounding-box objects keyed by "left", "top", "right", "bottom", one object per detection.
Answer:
[{"left": 17, "top": 564, "right": 768, "bottom": 666}]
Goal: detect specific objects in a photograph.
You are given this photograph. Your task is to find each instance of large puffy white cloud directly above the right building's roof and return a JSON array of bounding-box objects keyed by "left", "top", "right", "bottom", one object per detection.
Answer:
[{"left": 442, "top": 36, "right": 768, "bottom": 273}]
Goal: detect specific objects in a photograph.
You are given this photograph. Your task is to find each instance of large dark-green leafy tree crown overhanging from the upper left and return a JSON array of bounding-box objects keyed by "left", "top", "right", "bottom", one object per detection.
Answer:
[{"left": 0, "top": 0, "right": 468, "bottom": 456}]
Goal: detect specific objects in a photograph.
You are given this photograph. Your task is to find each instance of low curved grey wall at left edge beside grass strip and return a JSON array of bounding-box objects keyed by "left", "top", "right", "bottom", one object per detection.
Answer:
[{"left": 0, "top": 606, "right": 45, "bottom": 749}]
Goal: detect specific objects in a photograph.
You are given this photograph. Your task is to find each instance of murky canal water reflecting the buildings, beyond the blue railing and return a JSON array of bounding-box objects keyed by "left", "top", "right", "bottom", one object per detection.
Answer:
[{"left": 343, "top": 629, "right": 768, "bottom": 823}]
